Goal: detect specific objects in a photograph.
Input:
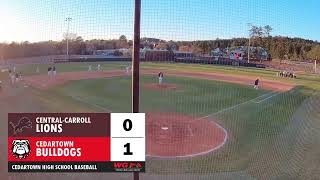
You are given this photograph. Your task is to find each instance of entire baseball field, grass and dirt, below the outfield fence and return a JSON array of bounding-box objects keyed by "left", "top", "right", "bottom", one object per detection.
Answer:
[{"left": 0, "top": 62, "right": 320, "bottom": 179}]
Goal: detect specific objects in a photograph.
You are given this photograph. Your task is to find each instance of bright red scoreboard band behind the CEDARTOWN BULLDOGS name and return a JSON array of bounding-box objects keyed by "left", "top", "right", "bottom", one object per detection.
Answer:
[{"left": 8, "top": 137, "right": 110, "bottom": 162}]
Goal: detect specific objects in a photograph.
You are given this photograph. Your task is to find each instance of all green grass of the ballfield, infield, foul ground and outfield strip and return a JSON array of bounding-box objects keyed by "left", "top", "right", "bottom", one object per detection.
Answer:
[{"left": 0, "top": 63, "right": 320, "bottom": 179}]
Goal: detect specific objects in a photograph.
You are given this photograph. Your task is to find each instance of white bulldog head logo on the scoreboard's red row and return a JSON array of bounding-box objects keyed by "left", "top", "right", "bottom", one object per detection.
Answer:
[{"left": 11, "top": 140, "right": 30, "bottom": 159}]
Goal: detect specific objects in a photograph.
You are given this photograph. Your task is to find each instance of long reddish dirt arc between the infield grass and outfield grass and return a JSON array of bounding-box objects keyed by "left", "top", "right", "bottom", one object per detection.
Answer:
[{"left": 24, "top": 69, "right": 295, "bottom": 92}]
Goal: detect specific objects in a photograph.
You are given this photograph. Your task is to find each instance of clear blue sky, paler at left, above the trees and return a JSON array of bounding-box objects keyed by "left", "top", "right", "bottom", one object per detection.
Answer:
[{"left": 0, "top": 0, "right": 320, "bottom": 42}]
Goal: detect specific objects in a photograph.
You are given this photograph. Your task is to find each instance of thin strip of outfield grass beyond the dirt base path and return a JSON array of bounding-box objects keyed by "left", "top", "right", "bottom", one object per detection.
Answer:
[{"left": 8, "top": 62, "right": 320, "bottom": 90}]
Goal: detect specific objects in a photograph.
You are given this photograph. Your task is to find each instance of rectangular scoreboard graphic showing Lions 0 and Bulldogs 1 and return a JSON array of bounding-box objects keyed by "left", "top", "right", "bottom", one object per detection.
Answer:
[{"left": 8, "top": 113, "right": 145, "bottom": 172}]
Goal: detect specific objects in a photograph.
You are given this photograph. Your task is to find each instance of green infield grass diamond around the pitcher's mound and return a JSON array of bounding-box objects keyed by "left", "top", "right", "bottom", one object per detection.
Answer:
[{"left": 53, "top": 76, "right": 267, "bottom": 116}]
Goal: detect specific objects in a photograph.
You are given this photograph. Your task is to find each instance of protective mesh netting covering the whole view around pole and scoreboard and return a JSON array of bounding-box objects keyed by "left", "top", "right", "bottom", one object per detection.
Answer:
[{"left": 0, "top": 0, "right": 320, "bottom": 180}]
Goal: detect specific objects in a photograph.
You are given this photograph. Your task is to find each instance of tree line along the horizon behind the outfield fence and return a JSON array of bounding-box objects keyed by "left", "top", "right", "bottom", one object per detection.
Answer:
[{"left": 0, "top": 25, "right": 320, "bottom": 61}]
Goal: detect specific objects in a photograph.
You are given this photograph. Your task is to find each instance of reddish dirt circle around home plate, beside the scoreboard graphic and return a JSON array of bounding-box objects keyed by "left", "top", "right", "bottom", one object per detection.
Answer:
[{"left": 146, "top": 113, "right": 228, "bottom": 158}]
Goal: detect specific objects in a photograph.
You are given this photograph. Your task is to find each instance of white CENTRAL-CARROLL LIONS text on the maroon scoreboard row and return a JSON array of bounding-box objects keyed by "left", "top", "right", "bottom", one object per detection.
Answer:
[{"left": 36, "top": 117, "right": 91, "bottom": 133}]
